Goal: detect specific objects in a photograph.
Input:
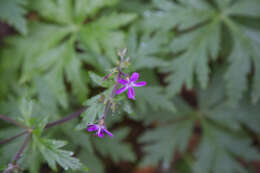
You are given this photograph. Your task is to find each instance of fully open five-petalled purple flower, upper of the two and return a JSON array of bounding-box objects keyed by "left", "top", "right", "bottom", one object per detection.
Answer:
[{"left": 116, "top": 72, "right": 146, "bottom": 99}]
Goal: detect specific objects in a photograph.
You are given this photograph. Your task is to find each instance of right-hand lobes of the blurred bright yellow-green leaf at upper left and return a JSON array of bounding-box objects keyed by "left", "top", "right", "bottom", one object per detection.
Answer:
[{"left": 80, "top": 13, "right": 136, "bottom": 63}]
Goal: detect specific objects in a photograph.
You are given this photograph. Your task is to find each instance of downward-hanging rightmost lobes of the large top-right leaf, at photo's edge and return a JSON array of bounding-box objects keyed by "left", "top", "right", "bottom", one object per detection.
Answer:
[{"left": 222, "top": 19, "right": 260, "bottom": 103}]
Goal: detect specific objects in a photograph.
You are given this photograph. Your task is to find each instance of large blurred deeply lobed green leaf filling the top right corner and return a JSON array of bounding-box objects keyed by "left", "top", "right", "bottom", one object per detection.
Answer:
[{"left": 143, "top": 0, "right": 260, "bottom": 103}]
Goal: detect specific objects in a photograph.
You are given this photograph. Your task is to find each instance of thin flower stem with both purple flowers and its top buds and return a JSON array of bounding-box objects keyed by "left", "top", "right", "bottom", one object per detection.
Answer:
[{"left": 87, "top": 50, "right": 146, "bottom": 138}]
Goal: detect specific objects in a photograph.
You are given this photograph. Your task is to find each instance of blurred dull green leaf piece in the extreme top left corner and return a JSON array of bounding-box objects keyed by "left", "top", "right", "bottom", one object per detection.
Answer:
[{"left": 0, "top": 0, "right": 27, "bottom": 34}]
